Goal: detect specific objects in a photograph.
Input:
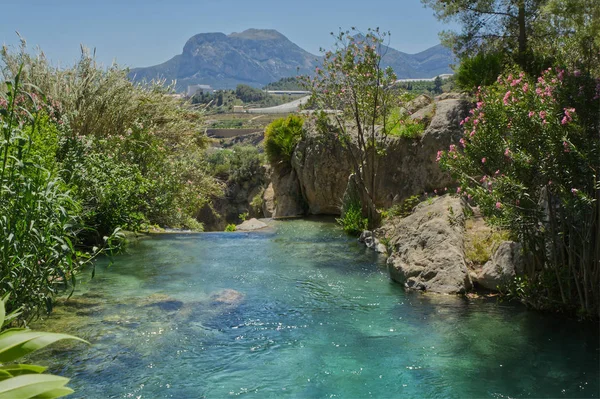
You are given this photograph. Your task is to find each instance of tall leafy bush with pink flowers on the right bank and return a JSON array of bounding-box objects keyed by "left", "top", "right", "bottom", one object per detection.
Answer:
[{"left": 438, "top": 68, "right": 600, "bottom": 315}]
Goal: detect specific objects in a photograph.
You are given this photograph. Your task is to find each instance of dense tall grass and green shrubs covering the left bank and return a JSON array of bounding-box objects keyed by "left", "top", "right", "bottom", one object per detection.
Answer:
[{"left": 0, "top": 42, "right": 221, "bottom": 319}]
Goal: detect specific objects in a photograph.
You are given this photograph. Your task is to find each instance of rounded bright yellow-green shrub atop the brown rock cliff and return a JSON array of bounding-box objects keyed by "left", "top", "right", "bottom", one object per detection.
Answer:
[{"left": 264, "top": 115, "right": 304, "bottom": 164}]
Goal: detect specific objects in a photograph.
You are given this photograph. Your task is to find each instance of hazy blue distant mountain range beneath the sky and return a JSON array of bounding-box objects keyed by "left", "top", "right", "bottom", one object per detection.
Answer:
[{"left": 129, "top": 29, "right": 453, "bottom": 91}]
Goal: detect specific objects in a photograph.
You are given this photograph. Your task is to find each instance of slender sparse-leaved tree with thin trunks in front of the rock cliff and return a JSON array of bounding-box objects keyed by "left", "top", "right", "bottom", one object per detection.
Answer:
[{"left": 302, "top": 28, "right": 396, "bottom": 226}]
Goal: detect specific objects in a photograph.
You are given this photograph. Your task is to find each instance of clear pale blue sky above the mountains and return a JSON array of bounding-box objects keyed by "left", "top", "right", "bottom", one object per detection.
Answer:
[{"left": 0, "top": 0, "right": 458, "bottom": 67}]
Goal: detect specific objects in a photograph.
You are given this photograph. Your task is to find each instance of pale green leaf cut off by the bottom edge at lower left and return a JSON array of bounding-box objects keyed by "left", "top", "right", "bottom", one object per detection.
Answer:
[{"left": 0, "top": 374, "right": 72, "bottom": 399}]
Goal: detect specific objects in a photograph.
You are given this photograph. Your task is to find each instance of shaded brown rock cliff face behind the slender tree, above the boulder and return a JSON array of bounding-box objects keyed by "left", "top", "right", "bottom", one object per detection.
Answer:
[{"left": 273, "top": 98, "right": 469, "bottom": 216}]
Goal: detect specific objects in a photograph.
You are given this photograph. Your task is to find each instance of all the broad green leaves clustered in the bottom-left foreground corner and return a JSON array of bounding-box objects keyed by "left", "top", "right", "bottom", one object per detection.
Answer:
[{"left": 0, "top": 296, "right": 86, "bottom": 399}]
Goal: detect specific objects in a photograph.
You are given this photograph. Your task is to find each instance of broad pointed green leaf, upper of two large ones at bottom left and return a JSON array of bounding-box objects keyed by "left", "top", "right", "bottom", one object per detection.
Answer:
[{"left": 0, "top": 328, "right": 88, "bottom": 363}]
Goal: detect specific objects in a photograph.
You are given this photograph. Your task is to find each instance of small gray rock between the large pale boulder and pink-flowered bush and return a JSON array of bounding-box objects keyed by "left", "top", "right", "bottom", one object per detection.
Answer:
[{"left": 477, "top": 241, "right": 523, "bottom": 291}]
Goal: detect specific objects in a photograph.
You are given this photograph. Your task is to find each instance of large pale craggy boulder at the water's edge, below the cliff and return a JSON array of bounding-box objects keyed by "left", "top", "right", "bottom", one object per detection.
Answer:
[{"left": 375, "top": 195, "right": 471, "bottom": 294}]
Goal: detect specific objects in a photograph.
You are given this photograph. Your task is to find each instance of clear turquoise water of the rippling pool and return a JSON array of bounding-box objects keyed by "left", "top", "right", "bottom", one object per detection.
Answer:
[{"left": 36, "top": 220, "right": 600, "bottom": 399}]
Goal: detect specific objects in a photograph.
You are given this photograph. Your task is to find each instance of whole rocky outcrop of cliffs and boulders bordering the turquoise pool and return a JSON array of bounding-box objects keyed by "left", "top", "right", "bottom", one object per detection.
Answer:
[{"left": 203, "top": 94, "right": 519, "bottom": 294}]
